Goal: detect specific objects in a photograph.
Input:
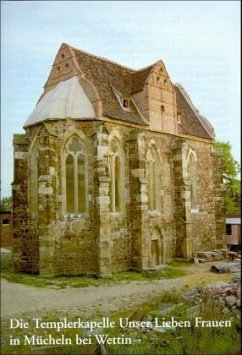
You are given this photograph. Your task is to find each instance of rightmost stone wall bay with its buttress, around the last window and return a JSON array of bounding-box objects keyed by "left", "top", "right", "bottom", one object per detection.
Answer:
[{"left": 169, "top": 139, "right": 225, "bottom": 258}]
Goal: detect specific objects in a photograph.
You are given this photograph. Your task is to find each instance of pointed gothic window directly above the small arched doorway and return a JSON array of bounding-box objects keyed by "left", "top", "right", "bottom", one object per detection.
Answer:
[{"left": 146, "top": 146, "right": 159, "bottom": 211}]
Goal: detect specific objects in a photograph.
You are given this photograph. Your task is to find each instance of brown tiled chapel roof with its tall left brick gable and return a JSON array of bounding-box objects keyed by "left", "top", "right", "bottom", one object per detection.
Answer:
[{"left": 27, "top": 43, "right": 214, "bottom": 140}]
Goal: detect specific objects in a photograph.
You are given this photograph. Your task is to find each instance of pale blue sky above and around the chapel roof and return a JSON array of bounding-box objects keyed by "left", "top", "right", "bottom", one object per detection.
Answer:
[{"left": 1, "top": 1, "right": 241, "bottom": 197}]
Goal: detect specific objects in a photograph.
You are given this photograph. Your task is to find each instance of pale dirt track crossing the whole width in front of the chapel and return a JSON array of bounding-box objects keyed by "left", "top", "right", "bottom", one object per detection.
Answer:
[{"left": 1, "top": 262, "right": 235, "bottom": 319}]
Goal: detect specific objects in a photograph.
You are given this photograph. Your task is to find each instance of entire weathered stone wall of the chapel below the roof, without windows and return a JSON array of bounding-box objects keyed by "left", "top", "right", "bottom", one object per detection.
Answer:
[{"left": 13, "top": 119, "right": 225, "bottom": 276}]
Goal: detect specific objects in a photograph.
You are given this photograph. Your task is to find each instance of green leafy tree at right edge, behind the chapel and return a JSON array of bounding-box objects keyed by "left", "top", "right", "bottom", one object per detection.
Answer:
[{"left": 214, "top": 142, "right": 241, "bottom": 212}]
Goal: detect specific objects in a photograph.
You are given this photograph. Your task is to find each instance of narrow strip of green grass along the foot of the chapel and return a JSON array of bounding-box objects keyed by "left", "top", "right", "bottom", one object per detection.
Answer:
[{"left": 1, "top": 259, "right": 189, "bottom": 288}]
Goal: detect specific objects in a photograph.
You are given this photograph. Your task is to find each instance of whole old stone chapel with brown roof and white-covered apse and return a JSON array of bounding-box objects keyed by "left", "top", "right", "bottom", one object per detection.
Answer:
[{"left": 12, "top": 43, "right": 225, "bottom": 277}]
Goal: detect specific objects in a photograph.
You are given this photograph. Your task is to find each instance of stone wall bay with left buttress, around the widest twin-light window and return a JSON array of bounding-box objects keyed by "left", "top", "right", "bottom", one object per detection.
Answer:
[{"left": 36, "top": 122, "right": 98, "bottom": 275}]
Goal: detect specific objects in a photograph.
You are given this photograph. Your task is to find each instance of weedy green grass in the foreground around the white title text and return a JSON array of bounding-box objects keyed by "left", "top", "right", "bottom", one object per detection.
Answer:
[{"left": 2, "top": 290, "right": 240, "bottom": 355}]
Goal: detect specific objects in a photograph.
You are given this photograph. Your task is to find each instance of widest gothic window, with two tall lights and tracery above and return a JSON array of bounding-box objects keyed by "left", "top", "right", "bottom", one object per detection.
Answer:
[{"left": 65, "top": 136, "right": 88, "bottom": 213}]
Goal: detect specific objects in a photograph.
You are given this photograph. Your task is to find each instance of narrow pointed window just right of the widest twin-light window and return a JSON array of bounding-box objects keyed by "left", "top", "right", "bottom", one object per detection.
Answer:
[{"left": 109, "top": 140, "right": 123, "bottom": 212}]
